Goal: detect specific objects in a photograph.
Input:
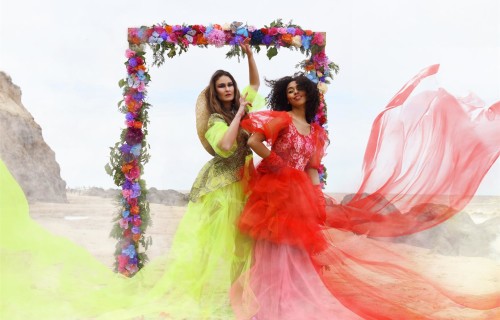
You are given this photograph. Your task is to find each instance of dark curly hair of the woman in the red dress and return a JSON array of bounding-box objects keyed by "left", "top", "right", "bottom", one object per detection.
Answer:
[{"left": 266, "top": 73, "right": 319, "bottom": 123}]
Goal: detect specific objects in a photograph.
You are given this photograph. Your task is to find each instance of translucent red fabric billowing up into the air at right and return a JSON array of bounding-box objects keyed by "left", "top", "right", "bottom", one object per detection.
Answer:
[{"left": 327, "top": 65, "right": 500, "bottom": 237}]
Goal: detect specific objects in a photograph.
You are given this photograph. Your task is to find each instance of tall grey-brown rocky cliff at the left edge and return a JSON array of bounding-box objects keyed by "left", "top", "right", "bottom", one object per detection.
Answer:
[{"left": 0, "top": 71, "right": 67, "bottom": 202}]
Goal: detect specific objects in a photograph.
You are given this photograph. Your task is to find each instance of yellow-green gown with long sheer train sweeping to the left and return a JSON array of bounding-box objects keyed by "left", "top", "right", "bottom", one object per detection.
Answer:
[{"left": 0, "top": 114, "right": 252, "bottom": 320}]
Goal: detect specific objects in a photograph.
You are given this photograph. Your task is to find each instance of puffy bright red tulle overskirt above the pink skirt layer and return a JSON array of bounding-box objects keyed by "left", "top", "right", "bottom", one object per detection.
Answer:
[{"left": 238, "top": 167, "right": 326, "bottom": 252}]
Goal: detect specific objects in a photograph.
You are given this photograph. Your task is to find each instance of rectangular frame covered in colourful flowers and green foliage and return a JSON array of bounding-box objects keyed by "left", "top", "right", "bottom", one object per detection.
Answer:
[{"left": 106, "top": 19, "right": 338, "bottom": 276}]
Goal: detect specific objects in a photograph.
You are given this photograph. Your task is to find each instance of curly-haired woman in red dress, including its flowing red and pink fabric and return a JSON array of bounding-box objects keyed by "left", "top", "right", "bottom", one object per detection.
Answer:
[{"left": 231, "top": 66, "right": 500, "bottom": 320}]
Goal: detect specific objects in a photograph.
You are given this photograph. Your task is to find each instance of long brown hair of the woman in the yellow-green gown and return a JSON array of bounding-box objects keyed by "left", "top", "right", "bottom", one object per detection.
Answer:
[{"left": 205, "top": 70, "right": 240, "bottom": 124}]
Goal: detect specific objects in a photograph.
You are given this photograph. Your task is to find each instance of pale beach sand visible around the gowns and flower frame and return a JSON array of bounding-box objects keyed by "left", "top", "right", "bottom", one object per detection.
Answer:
[{"left": 30, "top": 193, "right": 500, "bottom": 319}]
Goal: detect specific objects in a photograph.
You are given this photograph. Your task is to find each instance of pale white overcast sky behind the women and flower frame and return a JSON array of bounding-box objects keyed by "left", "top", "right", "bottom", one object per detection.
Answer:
[{"left": 0, "top": 0, "right": 500, "bottom": 195}]
